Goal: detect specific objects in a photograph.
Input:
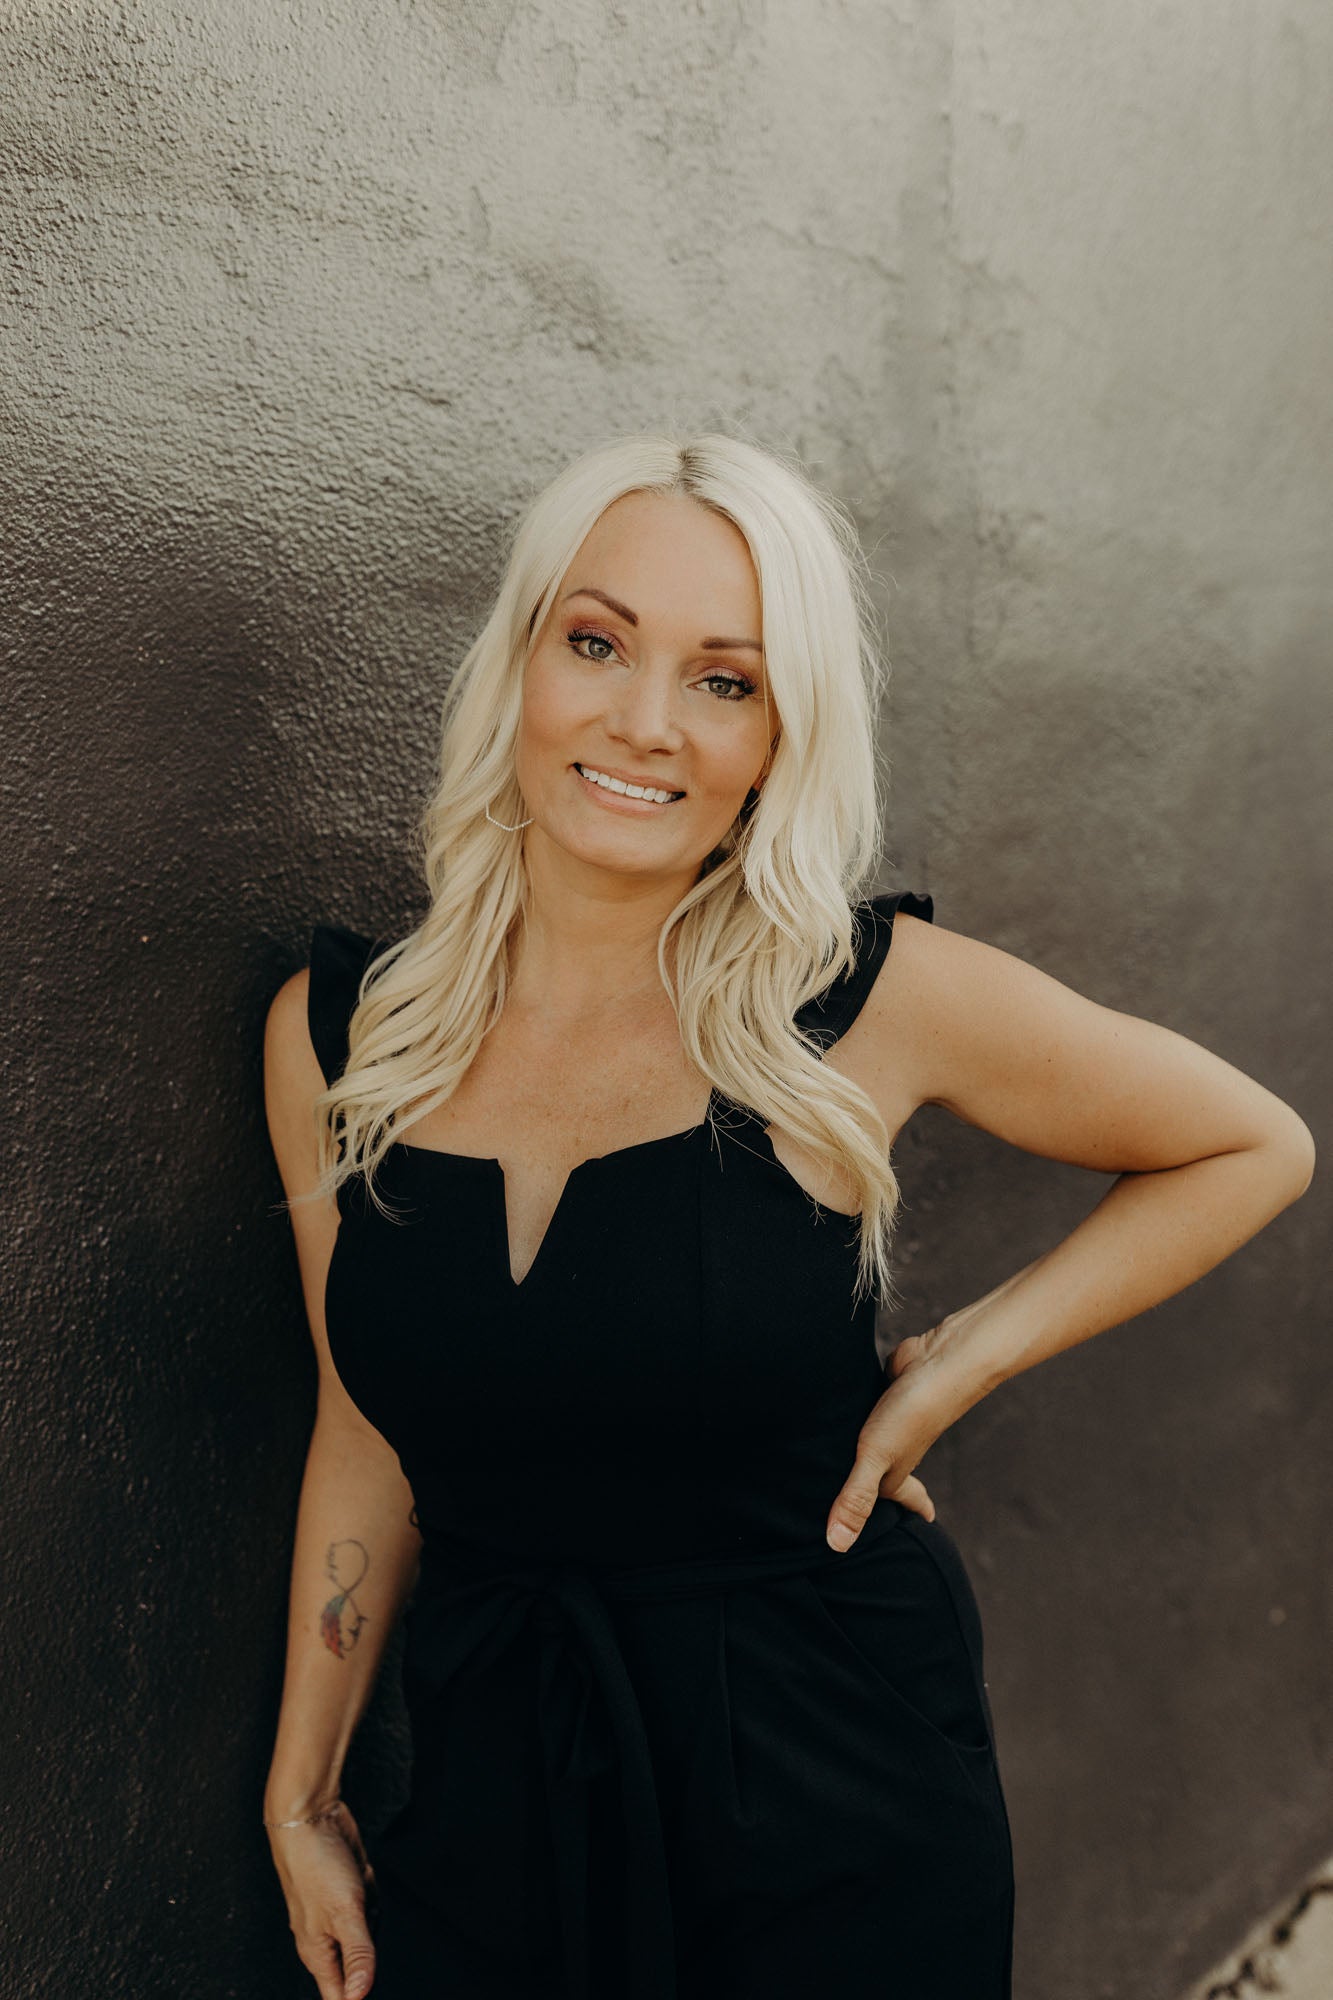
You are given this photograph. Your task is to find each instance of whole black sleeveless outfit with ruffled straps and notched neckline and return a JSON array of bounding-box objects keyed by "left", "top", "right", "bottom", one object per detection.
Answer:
[{"left": 310, "top": 892, "right": 1013, "bottom": 2000}]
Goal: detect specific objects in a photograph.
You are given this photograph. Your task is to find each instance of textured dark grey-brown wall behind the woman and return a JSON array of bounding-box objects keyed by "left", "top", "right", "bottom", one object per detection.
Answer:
[{"left": 0, "top": 0, "right": 1333, "bottom": 2000}]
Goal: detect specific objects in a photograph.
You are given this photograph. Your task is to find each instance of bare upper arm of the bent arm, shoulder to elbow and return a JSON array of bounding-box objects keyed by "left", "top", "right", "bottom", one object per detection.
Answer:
[{"left": 847, "top": 912, "right": 1311, "bottom": 1172}]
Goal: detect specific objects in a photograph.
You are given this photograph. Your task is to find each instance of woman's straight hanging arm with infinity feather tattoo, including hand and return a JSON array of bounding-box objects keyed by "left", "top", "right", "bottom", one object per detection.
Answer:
[{"left": 264, "top": 972, "right": 420, "bottom": 2000}]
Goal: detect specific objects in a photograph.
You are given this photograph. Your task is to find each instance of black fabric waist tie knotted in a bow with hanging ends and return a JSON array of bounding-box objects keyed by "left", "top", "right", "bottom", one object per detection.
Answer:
[{"left": 400, "top": 1500, "right": 907, "bottom": 2000}]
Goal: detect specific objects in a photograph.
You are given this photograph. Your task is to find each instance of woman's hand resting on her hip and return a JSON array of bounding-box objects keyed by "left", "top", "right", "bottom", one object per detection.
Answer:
[{"left": 825, "top": 1322, "right": 969, "bottom": 1554}]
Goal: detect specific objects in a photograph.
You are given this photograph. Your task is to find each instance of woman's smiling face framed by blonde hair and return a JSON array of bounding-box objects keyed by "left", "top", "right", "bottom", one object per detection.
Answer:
[{"left": 514, "top": 492, "right": 777, "bottom": 880}]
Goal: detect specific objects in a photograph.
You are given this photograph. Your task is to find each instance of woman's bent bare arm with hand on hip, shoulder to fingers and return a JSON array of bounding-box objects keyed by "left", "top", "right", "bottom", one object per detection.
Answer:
[{"left": 829, "top": 914, "right": 1315, "bottom": 1548}]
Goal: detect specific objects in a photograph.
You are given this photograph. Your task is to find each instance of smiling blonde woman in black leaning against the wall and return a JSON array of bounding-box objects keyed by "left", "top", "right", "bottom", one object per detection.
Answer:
[{"left": 264, "top": 434, "right": 1313, "bottom": 2000}]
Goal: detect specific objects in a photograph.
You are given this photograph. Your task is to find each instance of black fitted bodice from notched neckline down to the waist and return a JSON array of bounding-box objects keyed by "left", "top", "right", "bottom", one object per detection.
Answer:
[{"left": 324, "top": 1106, "right": 883, "bottom": 1560}]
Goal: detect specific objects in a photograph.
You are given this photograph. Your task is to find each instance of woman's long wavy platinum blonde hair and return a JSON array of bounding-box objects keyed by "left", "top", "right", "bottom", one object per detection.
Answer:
[{"left": 314, "top": 432, "right": 899, "bottom": 1302}]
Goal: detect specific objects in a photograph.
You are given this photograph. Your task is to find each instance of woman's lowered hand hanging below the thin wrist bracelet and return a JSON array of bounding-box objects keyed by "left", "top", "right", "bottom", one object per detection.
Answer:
[{"left": 268, "top": 1800, "right": 374, "bottom": 2000}]
